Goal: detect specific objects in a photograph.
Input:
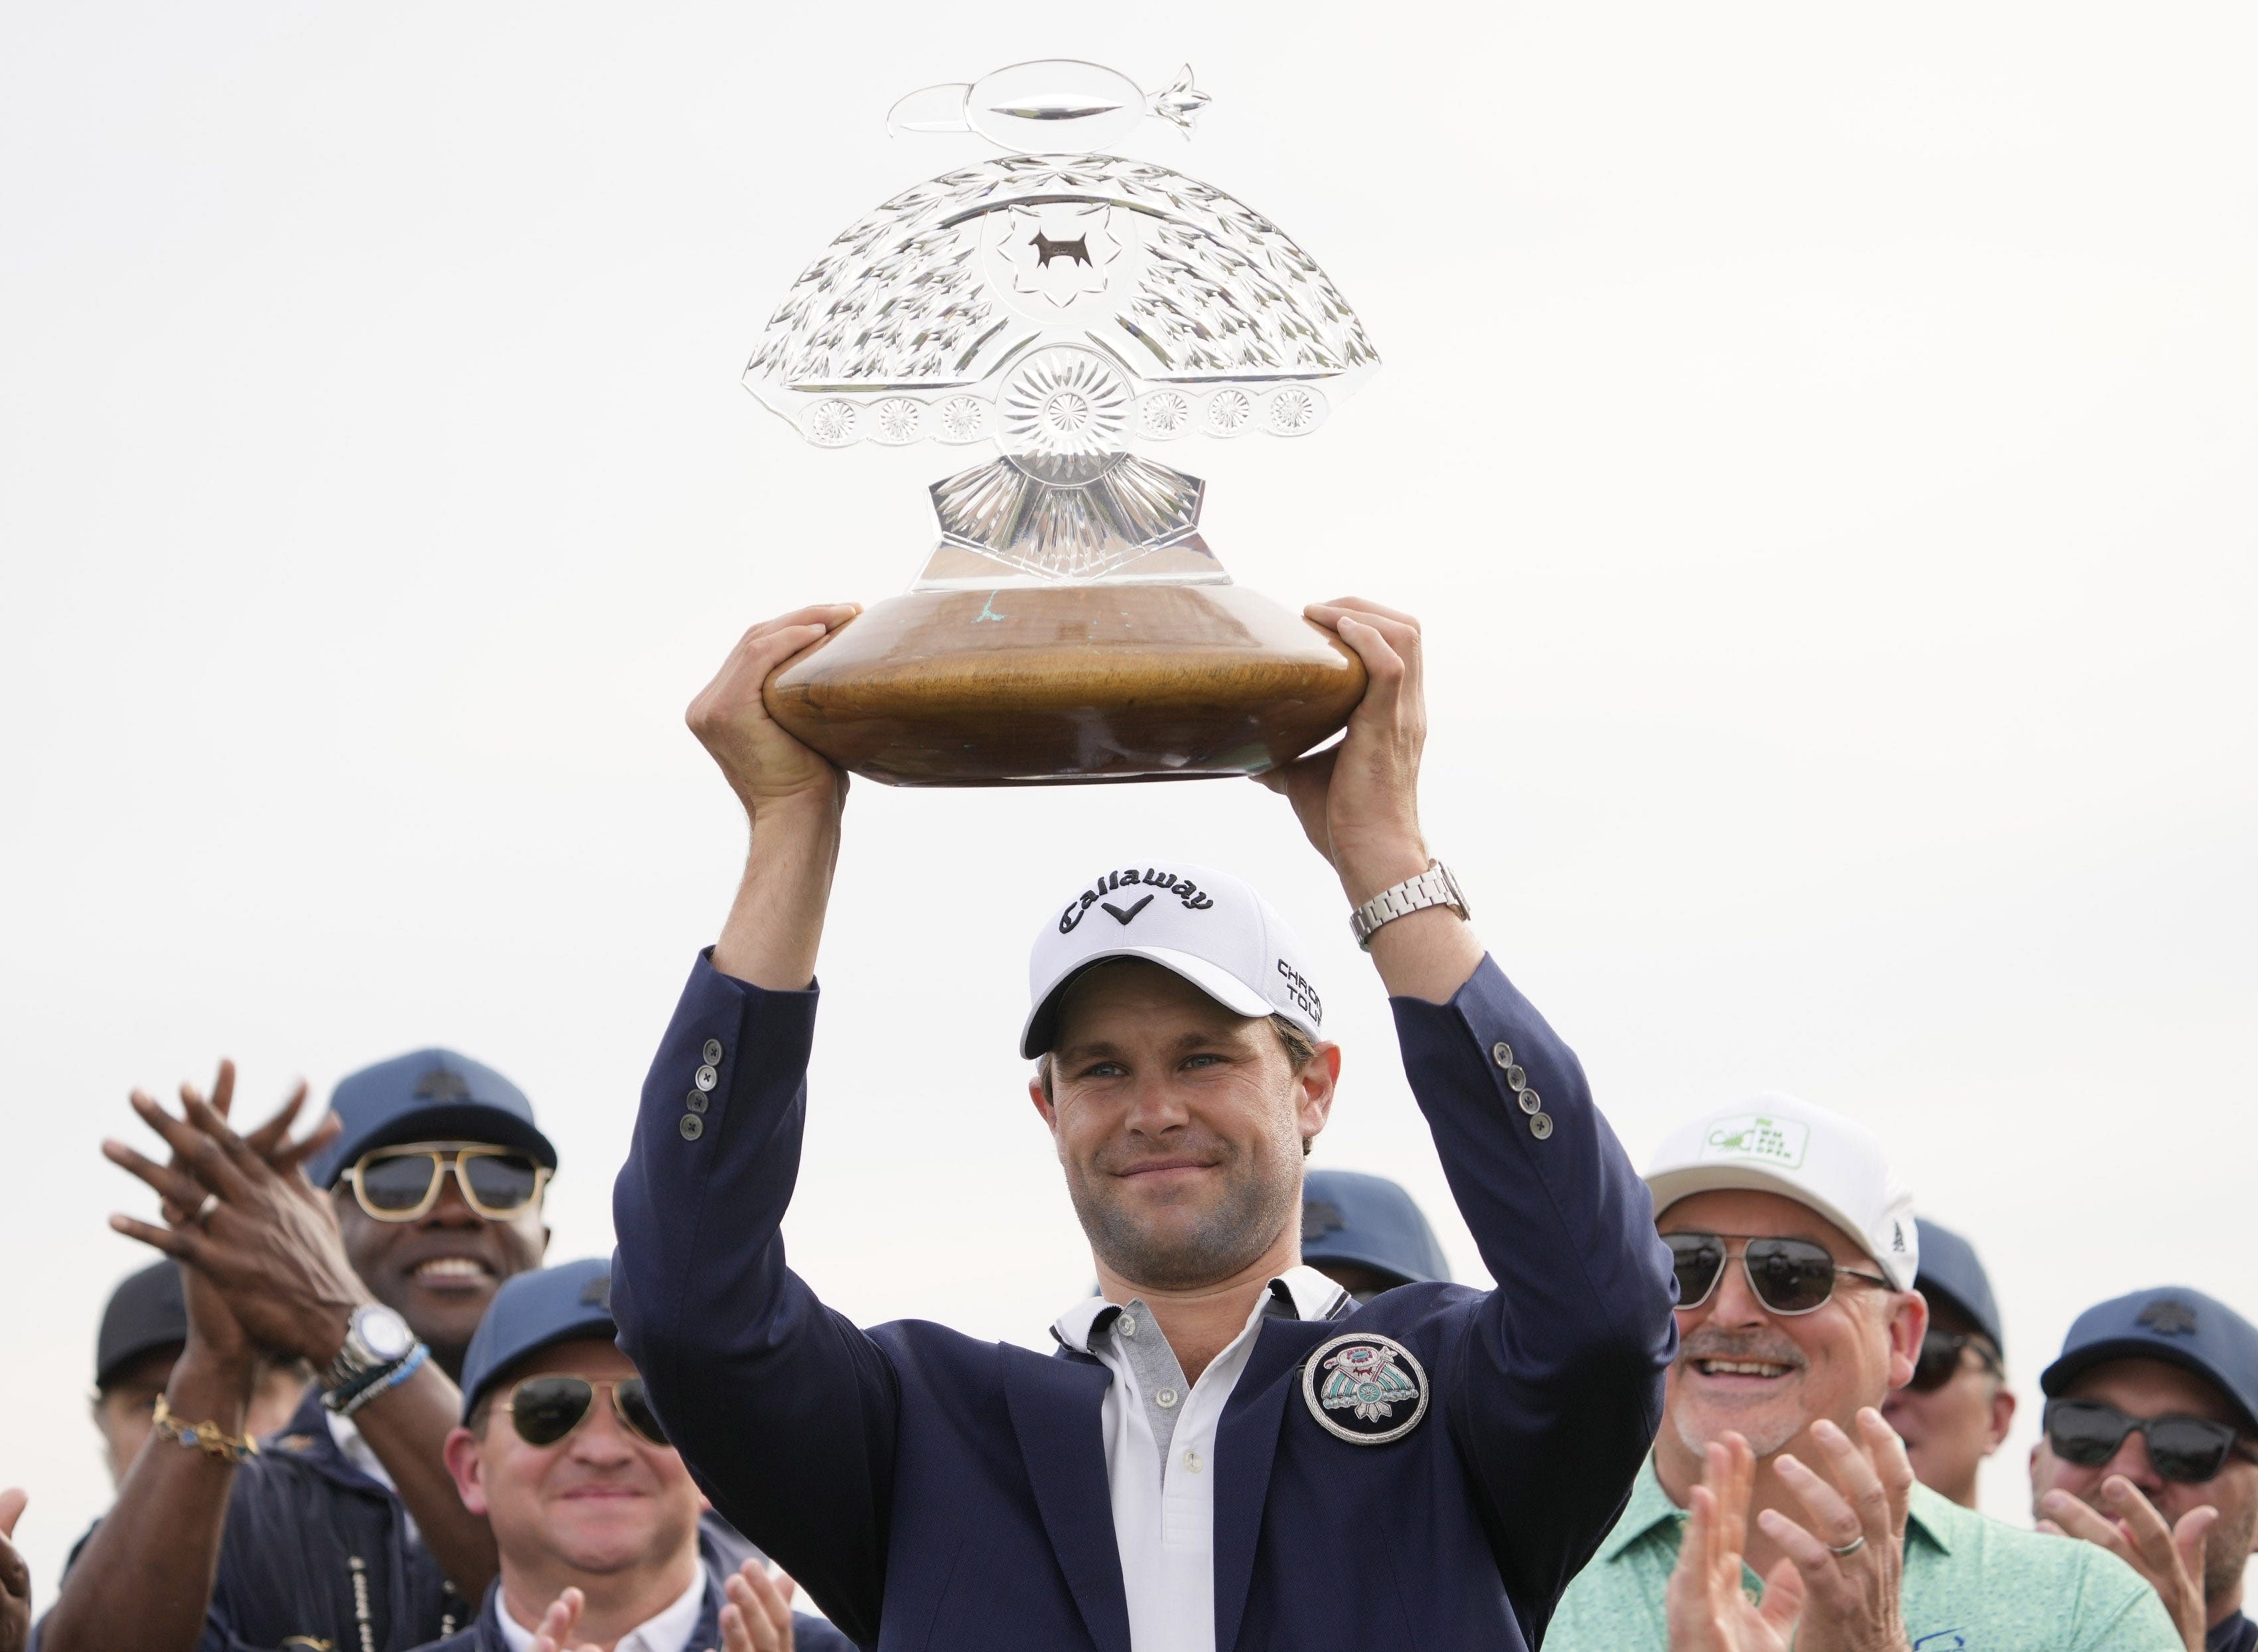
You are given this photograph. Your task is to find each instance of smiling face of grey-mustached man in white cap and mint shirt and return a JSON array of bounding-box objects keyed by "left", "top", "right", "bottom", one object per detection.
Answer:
[{"left": 1655, "top": 1189, "right": 1929, "bottom": 1485}]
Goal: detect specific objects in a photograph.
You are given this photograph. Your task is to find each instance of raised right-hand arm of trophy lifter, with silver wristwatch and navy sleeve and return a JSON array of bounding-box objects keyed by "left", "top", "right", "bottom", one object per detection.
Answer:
[{"left": 1266, "top": 598, "right": 1678, "bottom": 1620}]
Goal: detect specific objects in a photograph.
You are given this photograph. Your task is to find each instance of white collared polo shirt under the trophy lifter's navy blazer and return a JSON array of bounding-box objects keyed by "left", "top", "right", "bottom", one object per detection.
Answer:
[{"left": 1050, "top": 1266, "right": 1348, "bottom": 1652}]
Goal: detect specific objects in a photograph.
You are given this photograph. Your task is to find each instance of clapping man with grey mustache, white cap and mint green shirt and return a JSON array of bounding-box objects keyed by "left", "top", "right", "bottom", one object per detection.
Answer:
[{"left": 1547, "top": 1094, "right": 2181, "bottom": 1652}]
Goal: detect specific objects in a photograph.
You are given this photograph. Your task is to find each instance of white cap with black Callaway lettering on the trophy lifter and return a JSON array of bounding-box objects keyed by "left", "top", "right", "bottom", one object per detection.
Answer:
[{"left": 1018, "top": 860, "right": 1326, "bottom": 1060}]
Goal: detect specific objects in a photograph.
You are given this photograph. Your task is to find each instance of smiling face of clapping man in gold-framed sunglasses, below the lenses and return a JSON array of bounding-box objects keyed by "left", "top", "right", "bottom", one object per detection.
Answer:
[{"left": 332, "top": 1146, "right": 549, "bottom": 1374}]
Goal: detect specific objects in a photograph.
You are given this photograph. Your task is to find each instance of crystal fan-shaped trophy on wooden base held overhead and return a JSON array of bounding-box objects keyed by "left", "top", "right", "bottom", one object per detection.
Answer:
[{"left": 745, "top": 61, "right": 1379, "bottom": 785}]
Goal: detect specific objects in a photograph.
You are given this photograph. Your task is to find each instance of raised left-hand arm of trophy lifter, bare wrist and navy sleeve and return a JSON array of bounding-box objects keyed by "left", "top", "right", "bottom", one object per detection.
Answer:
[{"left": 612, "top": 607, "right": 899, "bottom": 1643}]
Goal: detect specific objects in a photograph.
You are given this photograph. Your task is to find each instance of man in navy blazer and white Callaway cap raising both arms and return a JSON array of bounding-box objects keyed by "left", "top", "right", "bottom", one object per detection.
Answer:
[{"left": 614, "top": 600, "right": 1673, "bottom": 1652}]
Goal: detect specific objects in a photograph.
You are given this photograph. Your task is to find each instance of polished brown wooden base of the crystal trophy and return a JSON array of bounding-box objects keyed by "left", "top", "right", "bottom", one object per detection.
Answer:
[{"left": 763, "top": 584, "right": 1364, "bottom": 785}]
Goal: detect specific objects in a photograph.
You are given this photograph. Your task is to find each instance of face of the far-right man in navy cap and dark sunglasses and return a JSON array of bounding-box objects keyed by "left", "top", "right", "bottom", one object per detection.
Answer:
[{"left": 2030, "top": 1359, "right": 2258, "bottom": 1607}]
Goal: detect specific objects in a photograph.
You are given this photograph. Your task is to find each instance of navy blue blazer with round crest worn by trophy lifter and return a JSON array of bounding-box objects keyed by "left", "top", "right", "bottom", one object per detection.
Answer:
[{"left": 612, "top": 959, "right": 1678, "bottom": 1652}]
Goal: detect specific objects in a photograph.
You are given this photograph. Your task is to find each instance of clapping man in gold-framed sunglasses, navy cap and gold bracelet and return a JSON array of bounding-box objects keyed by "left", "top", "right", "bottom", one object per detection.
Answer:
[{"left": 41, "top": 1049, "right": 555, "bottom": 1652}]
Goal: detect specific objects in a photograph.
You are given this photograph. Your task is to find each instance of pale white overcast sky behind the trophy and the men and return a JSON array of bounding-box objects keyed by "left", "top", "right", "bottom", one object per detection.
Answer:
[{"left": 0, "top": 5, "right": 2258, "bottom": 1600}]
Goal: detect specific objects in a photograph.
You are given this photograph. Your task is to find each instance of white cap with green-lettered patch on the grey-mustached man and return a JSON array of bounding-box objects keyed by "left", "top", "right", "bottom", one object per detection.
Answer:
[{"left": 1646, "top": 1094, "right": 1921, "bottom": 1291}]
